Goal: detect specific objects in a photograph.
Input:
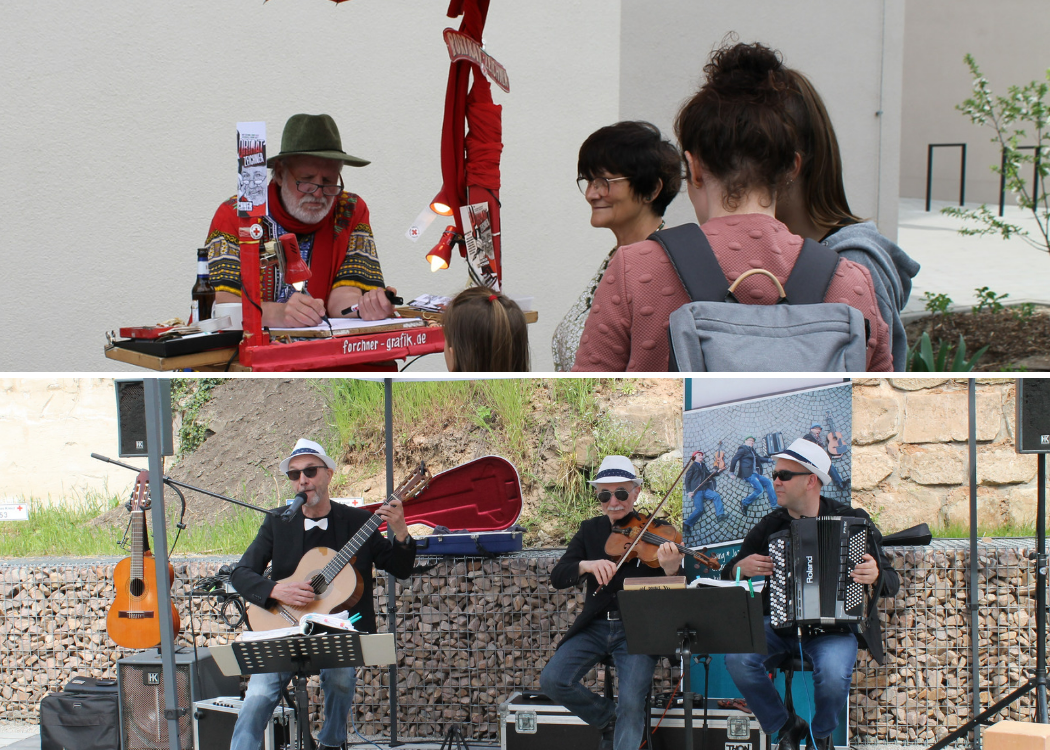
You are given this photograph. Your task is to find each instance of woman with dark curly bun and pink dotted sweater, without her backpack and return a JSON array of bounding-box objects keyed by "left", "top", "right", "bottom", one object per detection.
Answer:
[{"left": 573, "top": 43, "right": 893, "bottom": 372}]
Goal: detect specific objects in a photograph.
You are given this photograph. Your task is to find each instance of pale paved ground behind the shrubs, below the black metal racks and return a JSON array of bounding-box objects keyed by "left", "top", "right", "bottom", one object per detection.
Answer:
[{"left": 897, "top": 199, "right": 1050, "bottom": 313}]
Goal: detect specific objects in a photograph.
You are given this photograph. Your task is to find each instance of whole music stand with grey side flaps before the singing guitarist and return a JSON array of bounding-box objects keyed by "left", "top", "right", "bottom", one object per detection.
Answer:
[{"left": 211, "top": 632, "right": 397, "bottom": 750}]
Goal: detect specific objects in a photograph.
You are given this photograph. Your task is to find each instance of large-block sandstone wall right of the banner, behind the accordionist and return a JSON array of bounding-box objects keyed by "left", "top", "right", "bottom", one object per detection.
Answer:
[{"left": 853, "top": 378, "right": 1036, "bottom": 534}]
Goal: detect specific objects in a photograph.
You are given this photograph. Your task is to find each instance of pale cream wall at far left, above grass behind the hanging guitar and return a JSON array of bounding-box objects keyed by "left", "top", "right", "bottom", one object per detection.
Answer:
[{"left": 0, "top": 378, "right": 135, "bottom": 503}]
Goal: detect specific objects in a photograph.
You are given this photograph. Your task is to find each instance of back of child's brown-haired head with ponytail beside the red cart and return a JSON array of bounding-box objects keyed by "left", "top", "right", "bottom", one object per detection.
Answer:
[{"left": 443, "top": 287, "right": 529, "bottom": 373}]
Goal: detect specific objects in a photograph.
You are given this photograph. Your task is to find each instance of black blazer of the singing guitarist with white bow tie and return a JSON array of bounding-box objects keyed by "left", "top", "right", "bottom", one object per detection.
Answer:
[{"left": 230, "top": 495, "right": 416, "bottom": 632}]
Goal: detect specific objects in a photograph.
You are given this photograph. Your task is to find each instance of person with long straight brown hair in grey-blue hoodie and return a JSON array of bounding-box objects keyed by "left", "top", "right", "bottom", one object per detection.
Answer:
[{"left": 777, "top": 68, "right": 919, "bottom": 371}]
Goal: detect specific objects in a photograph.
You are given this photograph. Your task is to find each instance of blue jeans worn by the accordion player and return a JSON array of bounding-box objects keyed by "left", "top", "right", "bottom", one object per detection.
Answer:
[{"left": 726, "top": 618, "right": 857, "bottom": 738}]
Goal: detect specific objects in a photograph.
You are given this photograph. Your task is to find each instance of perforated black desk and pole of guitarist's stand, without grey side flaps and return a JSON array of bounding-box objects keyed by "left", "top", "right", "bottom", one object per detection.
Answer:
[{"left": 223, "top": 632, "right": 365, "bottom": 750}]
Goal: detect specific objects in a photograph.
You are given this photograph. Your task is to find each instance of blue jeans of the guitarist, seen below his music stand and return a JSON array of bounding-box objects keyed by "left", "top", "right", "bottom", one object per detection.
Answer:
[{"left": 230, "top": 667, "right": 357, "bottom": 750}]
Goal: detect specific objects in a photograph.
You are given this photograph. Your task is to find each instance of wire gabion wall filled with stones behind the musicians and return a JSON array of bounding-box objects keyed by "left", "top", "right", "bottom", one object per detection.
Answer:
[{"left": 0, "top": 540, "right": 1050, "bottom": 745}]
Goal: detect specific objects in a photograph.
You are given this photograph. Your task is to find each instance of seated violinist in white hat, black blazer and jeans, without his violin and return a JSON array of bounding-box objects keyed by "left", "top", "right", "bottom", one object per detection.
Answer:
[{"left": 540, "top": 456, "right": 685, "bottom": 750}]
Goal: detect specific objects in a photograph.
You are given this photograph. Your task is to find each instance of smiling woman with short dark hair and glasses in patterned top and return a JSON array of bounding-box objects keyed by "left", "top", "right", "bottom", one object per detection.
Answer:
[{"left": 551, "top": 122, "right": 681, "bottom": 371}]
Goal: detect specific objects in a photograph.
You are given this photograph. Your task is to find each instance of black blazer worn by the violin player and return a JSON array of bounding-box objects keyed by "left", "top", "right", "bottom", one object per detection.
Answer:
[{"left": 550, "top": 516, "right": 684, "bottom": 648}]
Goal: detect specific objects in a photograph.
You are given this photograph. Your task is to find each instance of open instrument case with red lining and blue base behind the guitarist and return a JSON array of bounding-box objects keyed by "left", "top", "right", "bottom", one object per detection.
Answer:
[{"left": 363, "top": 456, "right": 523, "bottom": 557}]
